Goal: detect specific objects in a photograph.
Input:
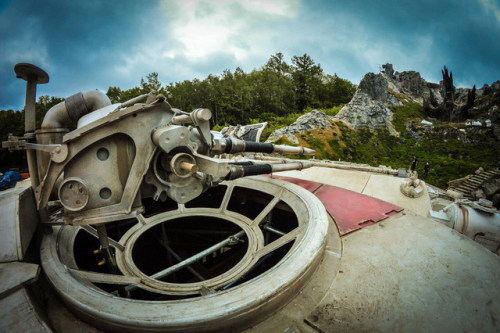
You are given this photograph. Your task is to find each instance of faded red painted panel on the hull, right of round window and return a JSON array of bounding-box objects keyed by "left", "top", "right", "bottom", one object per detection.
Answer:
[{"left": 273, "top": 176, "right": 403, "bottom": 236}]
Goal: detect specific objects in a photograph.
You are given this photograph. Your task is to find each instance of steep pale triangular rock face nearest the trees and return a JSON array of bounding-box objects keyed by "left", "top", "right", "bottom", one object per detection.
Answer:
[{"left": 335, "top": 73, "right": 402, "bottom": 135}]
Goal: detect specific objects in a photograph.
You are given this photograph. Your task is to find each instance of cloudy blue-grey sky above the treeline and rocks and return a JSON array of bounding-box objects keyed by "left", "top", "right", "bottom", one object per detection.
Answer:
[{"left": 0, "top": 0, "right": 500, "bottom": 110}]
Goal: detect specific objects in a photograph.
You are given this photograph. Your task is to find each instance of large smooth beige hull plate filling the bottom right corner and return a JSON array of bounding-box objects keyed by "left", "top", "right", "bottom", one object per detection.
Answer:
[{"left": 306, "top": 213, "right": 500, "bottom": 332}]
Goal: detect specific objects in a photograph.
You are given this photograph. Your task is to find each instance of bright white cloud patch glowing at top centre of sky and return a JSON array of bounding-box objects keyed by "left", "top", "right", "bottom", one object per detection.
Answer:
[{"left": 161, "top": 0, "right": 299, "bottom": 61}]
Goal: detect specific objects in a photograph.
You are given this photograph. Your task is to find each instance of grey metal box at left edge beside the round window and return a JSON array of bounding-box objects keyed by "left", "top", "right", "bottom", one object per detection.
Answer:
[{"left": 0, "top": 187, "right": 38, "bottom": 262}]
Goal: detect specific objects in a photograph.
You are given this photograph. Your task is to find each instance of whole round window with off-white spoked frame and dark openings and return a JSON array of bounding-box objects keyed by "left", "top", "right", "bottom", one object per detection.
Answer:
[{"left": 41, "top": 177, "right": 328, "bottom": 332}]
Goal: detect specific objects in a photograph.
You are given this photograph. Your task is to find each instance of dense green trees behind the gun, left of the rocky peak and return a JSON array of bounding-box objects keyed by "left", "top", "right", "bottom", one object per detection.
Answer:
[{"left": 162, "top": 53, "right": 356, "bottom": 126}]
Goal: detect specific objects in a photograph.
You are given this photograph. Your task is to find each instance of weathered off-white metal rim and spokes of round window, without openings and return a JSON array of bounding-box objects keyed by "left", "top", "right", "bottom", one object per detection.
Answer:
[{"left": 41, "top": 177, "right": 329, "bottom": 332}]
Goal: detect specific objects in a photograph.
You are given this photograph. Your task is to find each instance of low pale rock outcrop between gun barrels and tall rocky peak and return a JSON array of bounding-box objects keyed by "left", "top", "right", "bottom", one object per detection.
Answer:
[{"left": 266, "top": 110, "right": 332, "bottom": 144}]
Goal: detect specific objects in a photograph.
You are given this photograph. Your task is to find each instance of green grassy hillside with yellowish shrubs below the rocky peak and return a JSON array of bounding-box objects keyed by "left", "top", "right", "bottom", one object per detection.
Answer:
[{"left": 264, "top": 103, "right": 500, "bottom": 188}]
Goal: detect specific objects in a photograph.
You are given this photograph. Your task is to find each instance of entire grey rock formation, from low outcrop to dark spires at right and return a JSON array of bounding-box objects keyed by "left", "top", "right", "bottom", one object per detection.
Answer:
[{"left": 267, "top": 64, "right": 500, "bottom": 144}]
